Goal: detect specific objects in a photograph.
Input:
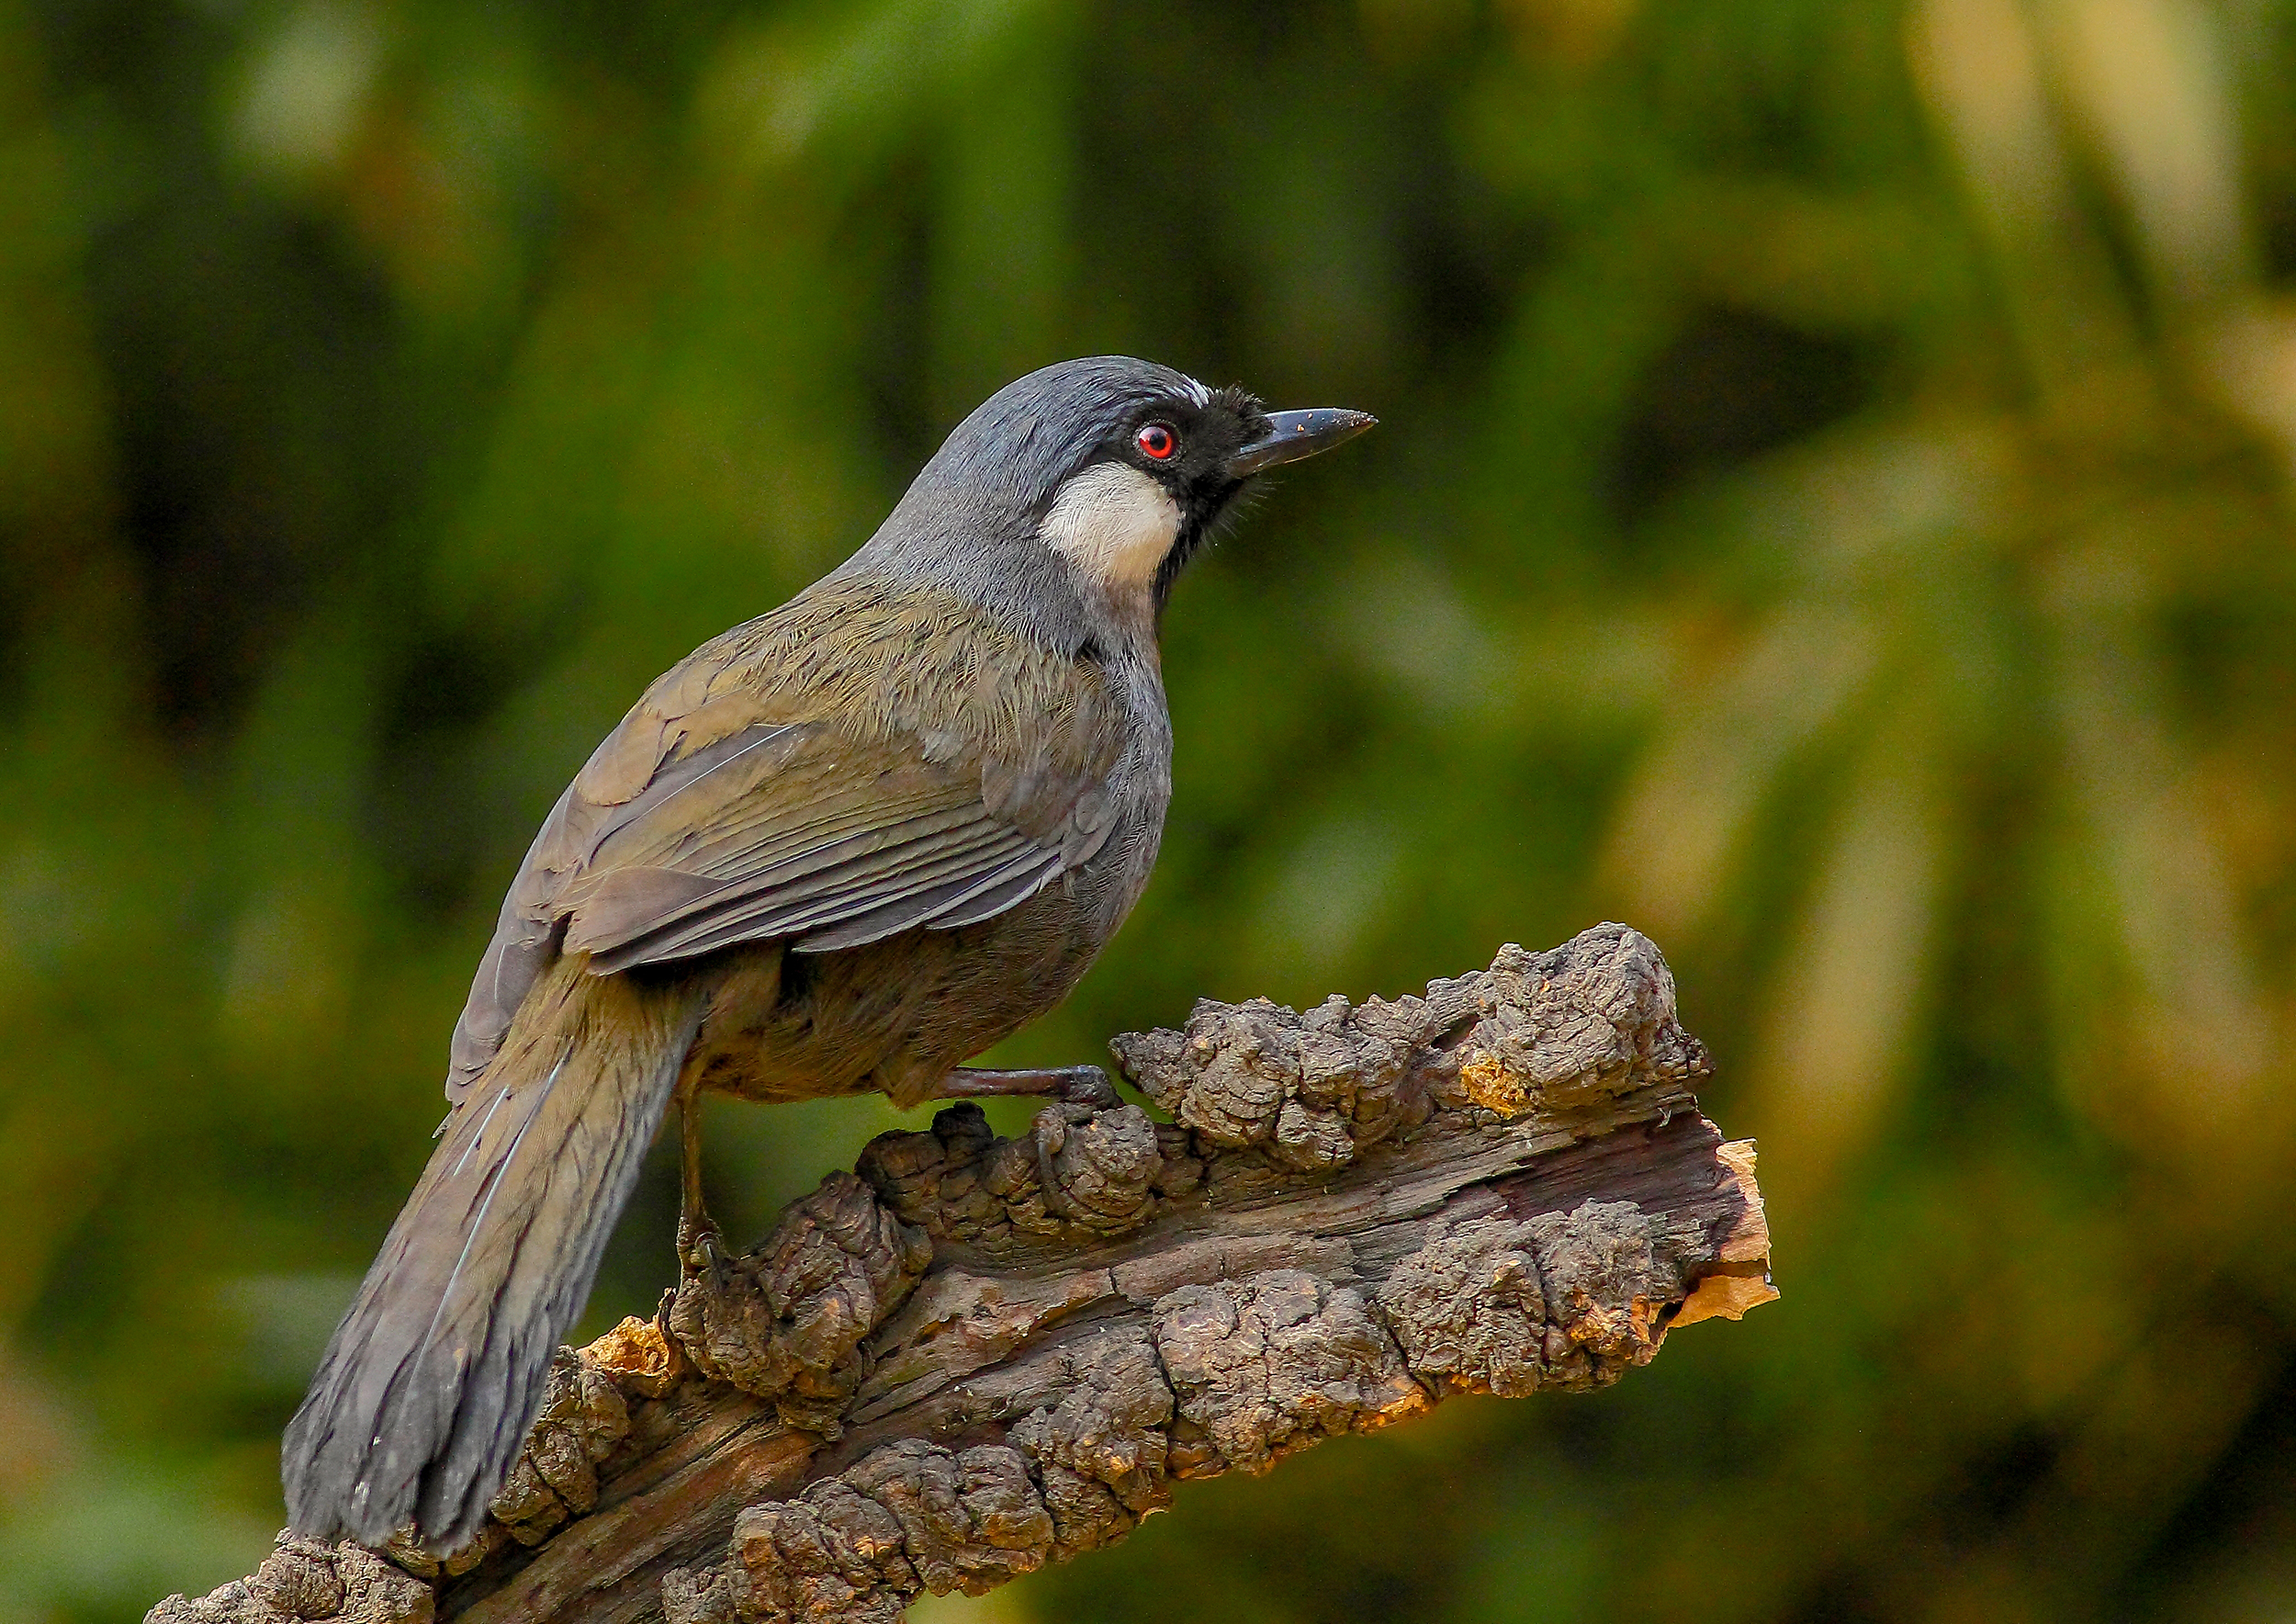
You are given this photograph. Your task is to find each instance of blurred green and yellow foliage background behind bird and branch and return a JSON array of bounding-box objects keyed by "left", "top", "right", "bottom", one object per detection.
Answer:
[{"left": 0, "top": 0, "right": 2296, "bottom": 1624}]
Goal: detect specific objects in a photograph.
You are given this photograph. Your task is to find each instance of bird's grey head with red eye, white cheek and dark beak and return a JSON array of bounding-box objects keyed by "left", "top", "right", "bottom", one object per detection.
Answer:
[{"left": 854, "top": 356, "right": 1376, "bottom": 629}]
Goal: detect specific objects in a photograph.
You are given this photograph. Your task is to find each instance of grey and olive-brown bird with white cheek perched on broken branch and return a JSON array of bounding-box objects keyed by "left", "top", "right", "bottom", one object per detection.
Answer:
[{"left": 280, "top": 356, "right": 1376, "bottom": 1552}]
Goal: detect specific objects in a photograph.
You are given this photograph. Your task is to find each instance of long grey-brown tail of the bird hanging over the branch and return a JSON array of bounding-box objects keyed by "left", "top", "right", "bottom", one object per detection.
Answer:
[{"left": 280, "top": 953, "right": 701, "bottom": 1551}]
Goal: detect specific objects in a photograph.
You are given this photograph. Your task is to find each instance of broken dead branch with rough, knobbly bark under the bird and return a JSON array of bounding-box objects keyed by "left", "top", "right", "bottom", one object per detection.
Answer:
[{"left": 150, "top": 926, "right": 1777, "bottom": 1624}]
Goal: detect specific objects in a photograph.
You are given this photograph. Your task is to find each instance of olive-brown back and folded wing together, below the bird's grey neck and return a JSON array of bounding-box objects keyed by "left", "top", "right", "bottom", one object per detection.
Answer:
[{"left": 448, "top": 581, "right": 1120, "bottom": 1098}]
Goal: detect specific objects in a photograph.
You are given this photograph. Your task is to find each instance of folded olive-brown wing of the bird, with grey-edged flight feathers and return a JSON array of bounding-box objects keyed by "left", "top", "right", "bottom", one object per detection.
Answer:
[{"left": 448, "top": 625, "right": 1111, "bottom": 1098}]
